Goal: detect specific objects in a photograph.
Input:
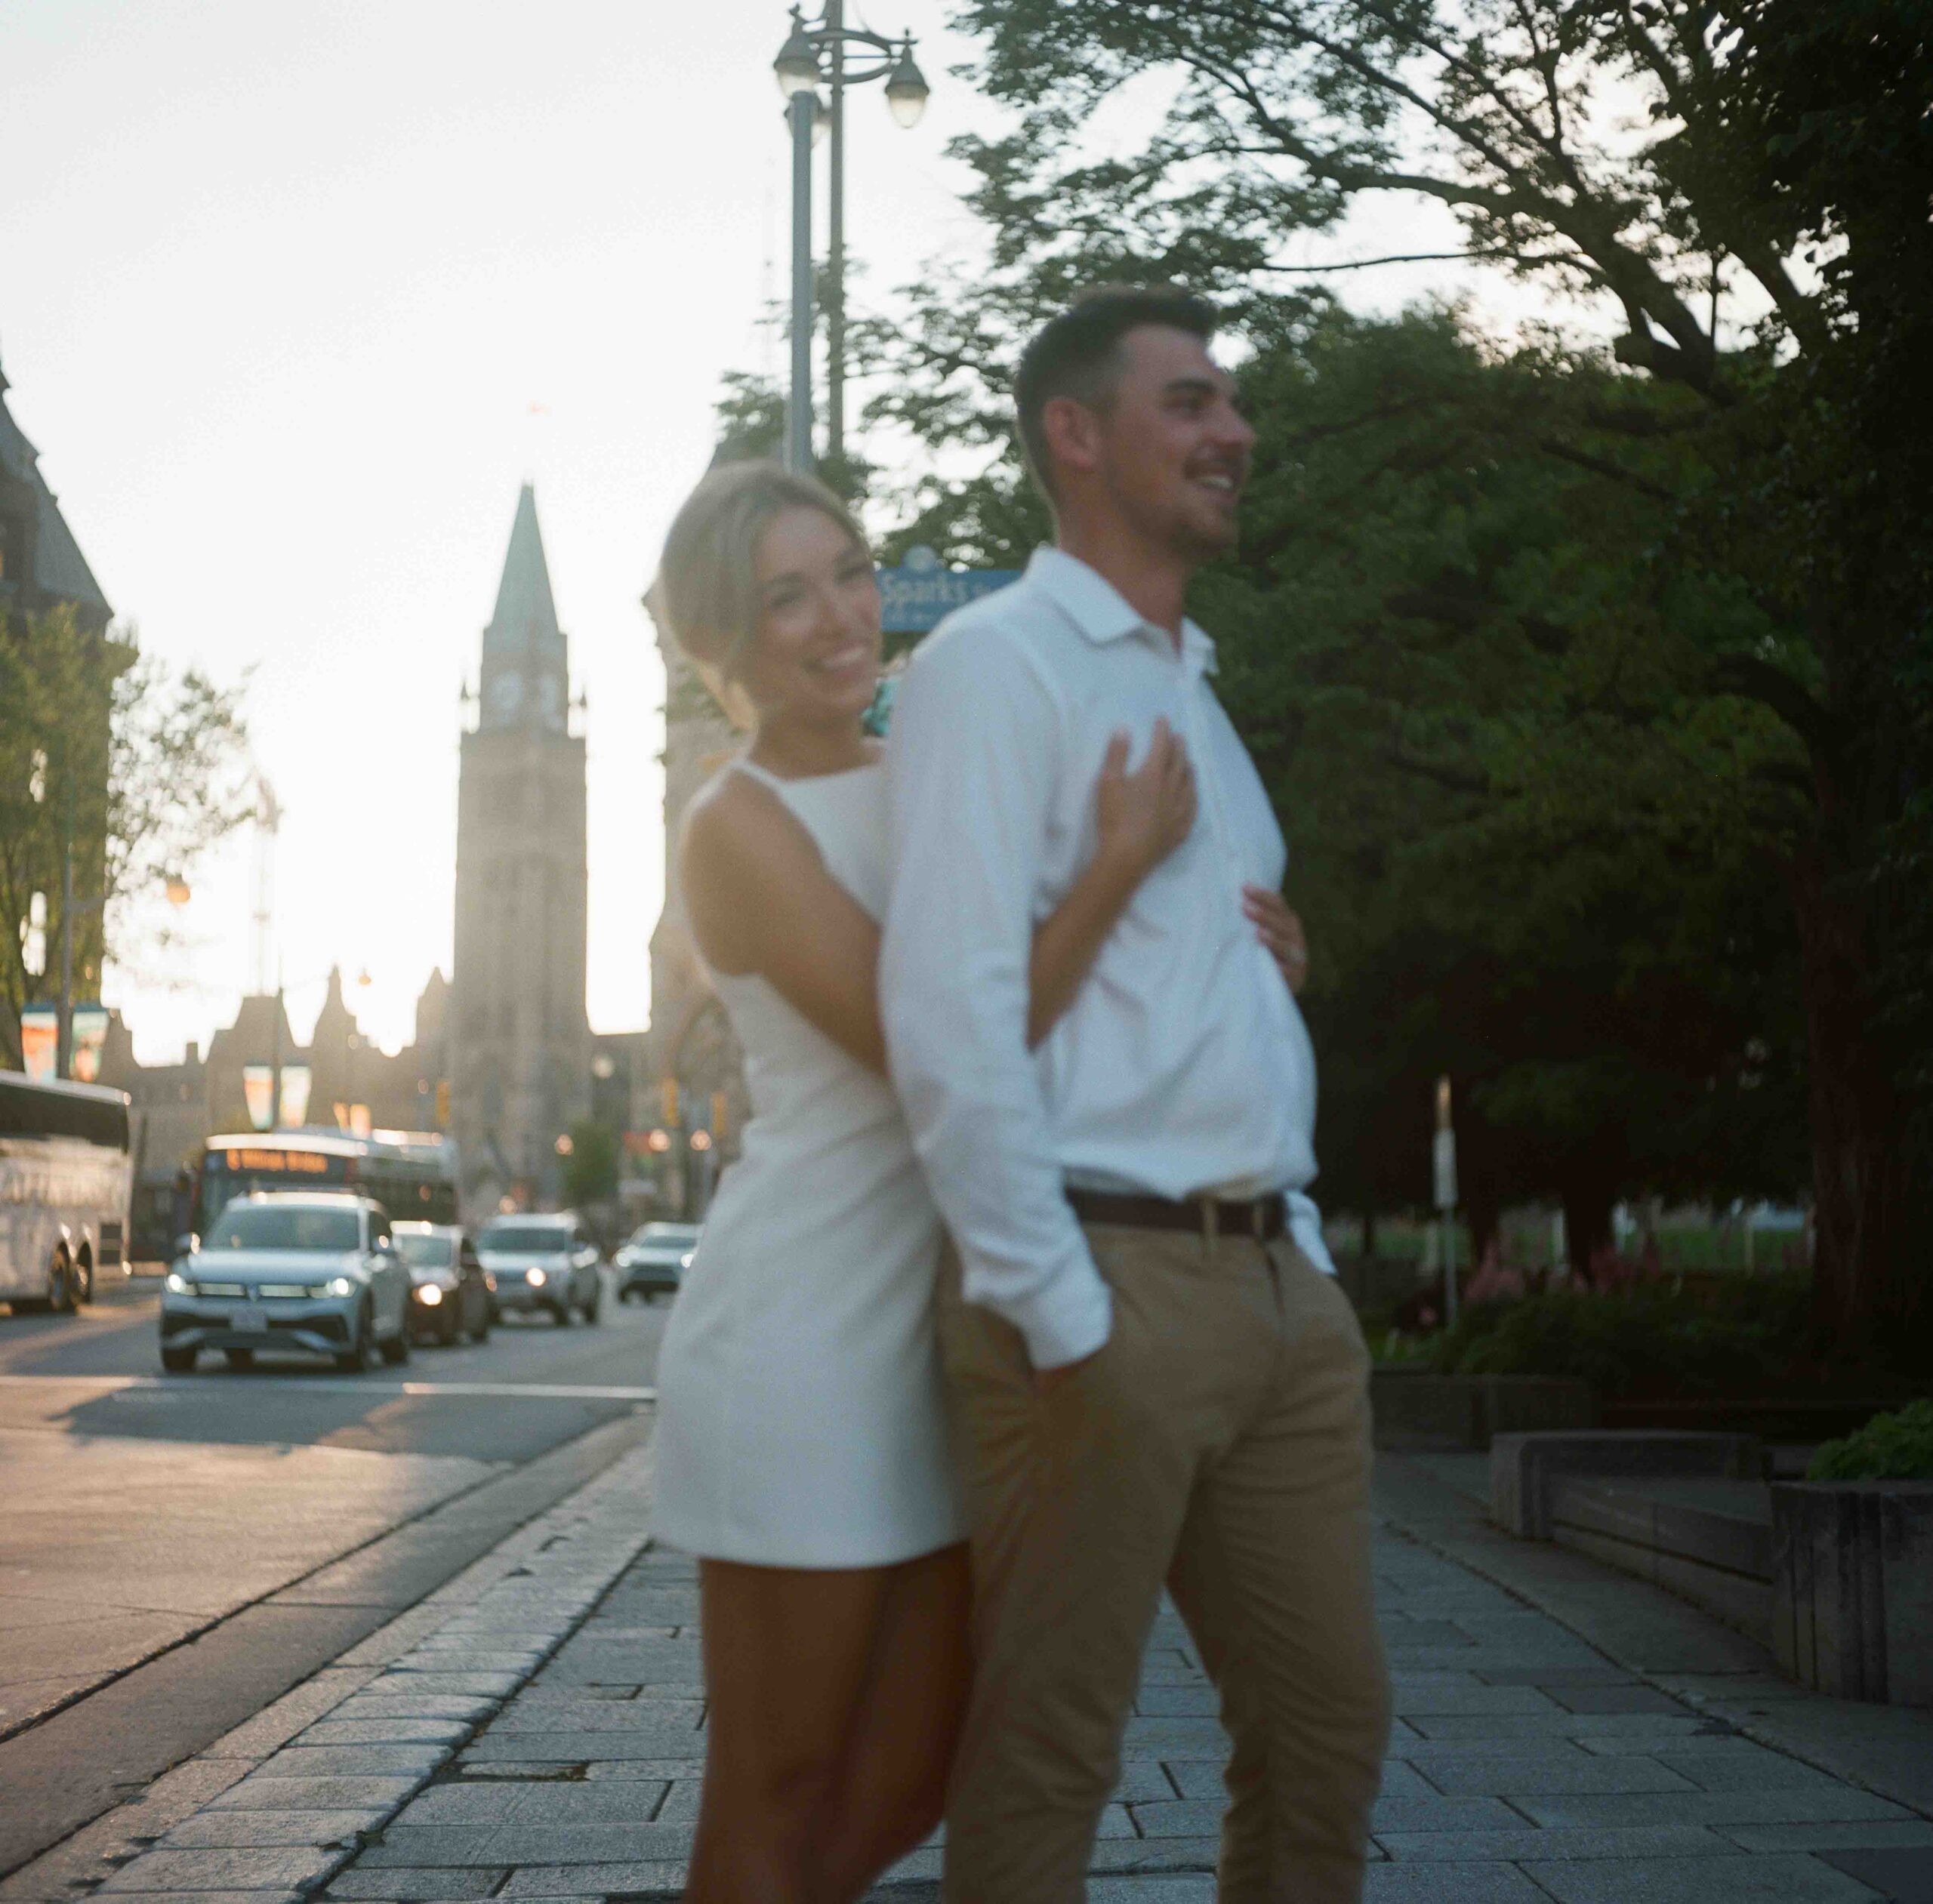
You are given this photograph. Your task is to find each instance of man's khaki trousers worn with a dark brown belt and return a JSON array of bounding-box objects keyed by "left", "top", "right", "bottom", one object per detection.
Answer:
[{"left": 939, "top": 1224, "right": 1390, "bottom": 1904}]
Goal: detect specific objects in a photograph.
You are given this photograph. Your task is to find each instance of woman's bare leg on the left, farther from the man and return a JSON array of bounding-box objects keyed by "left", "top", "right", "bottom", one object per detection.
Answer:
[{"left": 684, "top": 1560, "right": 893, "bottom": 1904}]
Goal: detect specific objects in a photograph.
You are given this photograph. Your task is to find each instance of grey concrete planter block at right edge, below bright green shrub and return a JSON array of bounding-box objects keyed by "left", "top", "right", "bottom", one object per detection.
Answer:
[{"left": 1773, "top": 1480, "right": 1933, "bottom": 1705}]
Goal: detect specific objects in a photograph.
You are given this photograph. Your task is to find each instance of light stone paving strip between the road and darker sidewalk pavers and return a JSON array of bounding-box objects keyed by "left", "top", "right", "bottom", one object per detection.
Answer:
[{"left": 17, "top": 1440, "right": 652, "bottom": 1904}]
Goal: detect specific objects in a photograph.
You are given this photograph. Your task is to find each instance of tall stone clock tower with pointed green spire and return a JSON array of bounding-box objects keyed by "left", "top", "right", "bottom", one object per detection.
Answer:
[{"left": 449, "top": 483, "right": 591, "bottom": 1222}]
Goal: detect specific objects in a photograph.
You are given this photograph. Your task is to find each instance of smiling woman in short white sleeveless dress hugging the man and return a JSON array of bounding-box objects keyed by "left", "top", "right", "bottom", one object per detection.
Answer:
[{"left": 653, "top": 464, "right": 1306, "bottom": 1904}]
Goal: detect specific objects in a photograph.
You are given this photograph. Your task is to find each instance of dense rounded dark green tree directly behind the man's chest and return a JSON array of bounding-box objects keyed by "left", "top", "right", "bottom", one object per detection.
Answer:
[{"left": 1202, "top": 310, "right": 1803, "bottom": 1265}]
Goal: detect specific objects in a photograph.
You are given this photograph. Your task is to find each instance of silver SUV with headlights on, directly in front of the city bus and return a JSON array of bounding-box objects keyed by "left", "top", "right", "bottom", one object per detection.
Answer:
[{"left": 160, "top": 1191, "right": 410, "bottom": 1374}]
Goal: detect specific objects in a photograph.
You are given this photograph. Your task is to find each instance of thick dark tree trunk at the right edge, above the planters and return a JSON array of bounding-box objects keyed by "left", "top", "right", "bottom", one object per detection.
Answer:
[{"left": 1792, "top": 852, "right": 1933, "bottom": 1355}]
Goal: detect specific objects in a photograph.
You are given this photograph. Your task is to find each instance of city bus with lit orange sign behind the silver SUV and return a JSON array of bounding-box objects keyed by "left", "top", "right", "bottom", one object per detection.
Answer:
[{"left": 189, "top": 1131, "right": 456, "bottom": 1249}]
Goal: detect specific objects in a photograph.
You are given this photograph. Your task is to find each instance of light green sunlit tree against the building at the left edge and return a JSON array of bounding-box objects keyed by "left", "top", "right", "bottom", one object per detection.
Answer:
[{"left": 0, "top": 609, "right": 249, "bottom": 1063}]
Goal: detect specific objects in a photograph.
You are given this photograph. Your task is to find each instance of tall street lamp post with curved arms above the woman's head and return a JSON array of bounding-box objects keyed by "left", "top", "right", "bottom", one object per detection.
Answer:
[{"left": 771, "top": 0, "right": 928, "bottom": 473}]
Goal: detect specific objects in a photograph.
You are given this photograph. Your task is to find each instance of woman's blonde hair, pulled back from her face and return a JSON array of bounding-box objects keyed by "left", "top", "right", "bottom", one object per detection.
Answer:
[{"left": 657, "top": 462, "right": 866, "bottom": 684}]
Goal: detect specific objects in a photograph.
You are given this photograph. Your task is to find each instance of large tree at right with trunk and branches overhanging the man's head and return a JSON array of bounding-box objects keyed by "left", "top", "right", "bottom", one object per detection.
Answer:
[{"left": 881, "top": 0, "right": 1933, "bottom": 1332}]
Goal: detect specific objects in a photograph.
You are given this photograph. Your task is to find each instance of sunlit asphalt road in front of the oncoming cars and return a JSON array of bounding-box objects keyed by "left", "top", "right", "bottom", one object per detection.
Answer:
[{"left": 0, "top": 1280, "right": 669, "bottom": 1875}]
